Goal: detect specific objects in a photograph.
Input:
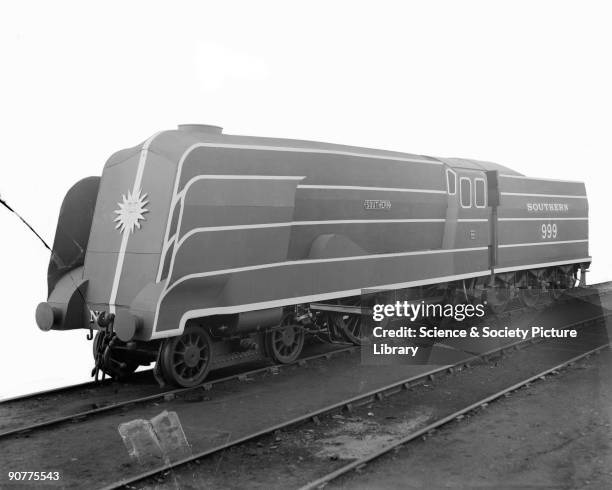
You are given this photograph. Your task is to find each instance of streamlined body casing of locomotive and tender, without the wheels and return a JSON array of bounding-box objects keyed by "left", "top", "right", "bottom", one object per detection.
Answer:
[{"left": 39, "top": 126, "right": 590, "bottom": 341}]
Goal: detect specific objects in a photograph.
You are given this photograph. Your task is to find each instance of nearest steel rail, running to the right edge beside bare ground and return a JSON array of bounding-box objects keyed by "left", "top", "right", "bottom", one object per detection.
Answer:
[{"left": 300, "top": 342, "right": 611, "bottom": 490}]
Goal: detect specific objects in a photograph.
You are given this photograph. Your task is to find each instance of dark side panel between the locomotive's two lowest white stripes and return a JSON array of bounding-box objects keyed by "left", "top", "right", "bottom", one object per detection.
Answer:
[{"left": 158, "top": 250, "right": 488, "bottom": 331}]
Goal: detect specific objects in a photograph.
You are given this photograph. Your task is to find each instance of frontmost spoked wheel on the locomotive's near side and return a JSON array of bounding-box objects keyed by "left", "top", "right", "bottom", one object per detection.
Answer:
[{"left": 161, "top": 325, "right": 212, "bottom": 388}]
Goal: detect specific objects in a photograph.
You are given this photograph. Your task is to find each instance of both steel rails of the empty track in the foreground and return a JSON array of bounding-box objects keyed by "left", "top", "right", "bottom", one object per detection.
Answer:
[{"left": 104, "top": 290, "right": 612, "bottom": 490}]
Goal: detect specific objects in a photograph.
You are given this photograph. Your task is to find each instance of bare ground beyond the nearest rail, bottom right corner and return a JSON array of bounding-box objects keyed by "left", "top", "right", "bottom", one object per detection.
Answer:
[{"left": 326, "top": 350, "right": 612, "bottom": 489}]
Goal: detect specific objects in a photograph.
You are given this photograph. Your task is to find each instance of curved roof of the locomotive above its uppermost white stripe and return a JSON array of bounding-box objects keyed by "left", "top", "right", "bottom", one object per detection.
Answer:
[{"left": 106, "top": 130, "right": 522, "bottom": 175}]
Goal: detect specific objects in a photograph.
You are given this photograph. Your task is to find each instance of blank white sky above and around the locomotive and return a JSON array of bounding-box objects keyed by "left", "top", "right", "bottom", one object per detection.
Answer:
[{"left": 0, "top": 0, "right": 612, "bottom": 397}]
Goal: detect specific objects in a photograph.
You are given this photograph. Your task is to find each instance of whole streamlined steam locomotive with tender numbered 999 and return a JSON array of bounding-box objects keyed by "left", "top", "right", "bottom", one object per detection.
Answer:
[{"left": 36, "top": 125, "right": 591, "bottom": 386}]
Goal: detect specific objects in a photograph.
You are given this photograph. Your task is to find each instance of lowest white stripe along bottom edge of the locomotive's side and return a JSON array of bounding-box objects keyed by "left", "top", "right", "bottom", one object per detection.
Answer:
[{"left": 151, "top": 270, "right": 491, "bottom": 339}]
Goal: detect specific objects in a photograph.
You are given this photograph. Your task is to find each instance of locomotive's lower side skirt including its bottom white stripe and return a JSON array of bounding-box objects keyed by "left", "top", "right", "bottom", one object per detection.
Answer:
[{"left": 154, "top": 247, "right": 490, "bottom": 338}]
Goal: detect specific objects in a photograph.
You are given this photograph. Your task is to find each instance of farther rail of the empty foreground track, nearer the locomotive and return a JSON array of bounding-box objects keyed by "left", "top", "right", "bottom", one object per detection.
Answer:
[{"left": 101, "top": 312, "right": 612, "bottom": 490}]
